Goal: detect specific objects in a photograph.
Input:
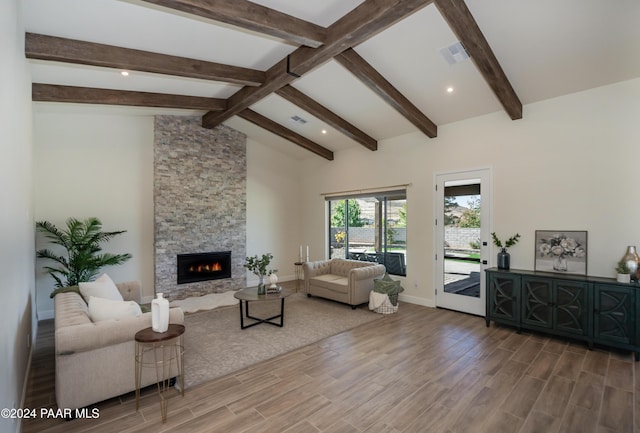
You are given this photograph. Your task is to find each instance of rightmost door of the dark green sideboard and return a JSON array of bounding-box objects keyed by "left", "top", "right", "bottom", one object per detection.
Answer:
[{"left": 594, "top": 285, "right": 635, "bottom": 344}]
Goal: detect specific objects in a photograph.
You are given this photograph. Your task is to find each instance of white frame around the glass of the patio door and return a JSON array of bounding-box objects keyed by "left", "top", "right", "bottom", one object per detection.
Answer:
[{"left": 434, "top": 168, "right": 493, "bottom": 317}]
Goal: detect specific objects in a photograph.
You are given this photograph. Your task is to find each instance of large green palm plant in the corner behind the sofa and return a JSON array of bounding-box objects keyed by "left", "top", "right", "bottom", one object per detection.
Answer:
[{"left": 36, "top": 217, "right": 131, "bottom": 288}]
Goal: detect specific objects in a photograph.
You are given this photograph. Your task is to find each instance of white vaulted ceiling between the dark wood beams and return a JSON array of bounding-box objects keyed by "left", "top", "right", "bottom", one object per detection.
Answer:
[{"left": 22, "top": 0, "right": 640, "bottom": 159}]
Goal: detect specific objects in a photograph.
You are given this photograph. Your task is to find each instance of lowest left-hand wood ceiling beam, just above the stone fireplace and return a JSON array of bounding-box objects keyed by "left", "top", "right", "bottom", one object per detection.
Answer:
[{"left": 31, "top": 83, "right": 227, "bottom": 110}]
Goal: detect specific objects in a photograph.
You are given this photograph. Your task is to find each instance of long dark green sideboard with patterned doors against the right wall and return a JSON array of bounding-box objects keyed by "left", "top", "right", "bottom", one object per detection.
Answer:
[{"left": 485, "top": 268, "right": 640, "bottom": 360}]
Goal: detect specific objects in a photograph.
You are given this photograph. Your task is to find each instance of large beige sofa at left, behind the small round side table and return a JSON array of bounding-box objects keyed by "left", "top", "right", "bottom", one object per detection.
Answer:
[{"left": 54, "top": 281, "right": 184, "bottom": 409}]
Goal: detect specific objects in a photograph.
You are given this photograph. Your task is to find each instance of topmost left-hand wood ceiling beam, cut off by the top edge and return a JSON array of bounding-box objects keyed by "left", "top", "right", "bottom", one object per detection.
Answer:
[{"left": 143, "top": 0, "right": 326, "bottom": 48}]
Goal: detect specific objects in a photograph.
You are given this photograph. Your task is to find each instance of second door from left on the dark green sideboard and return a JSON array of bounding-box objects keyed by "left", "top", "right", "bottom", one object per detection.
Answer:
[{"left": 522, "top": 278, "right": 553, "bottom": 328}]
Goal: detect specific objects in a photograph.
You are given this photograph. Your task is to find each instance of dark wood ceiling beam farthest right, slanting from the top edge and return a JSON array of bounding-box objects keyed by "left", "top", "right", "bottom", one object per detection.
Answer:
[{"left": 435, "top": 0, "right": 522, "bottom": 120}]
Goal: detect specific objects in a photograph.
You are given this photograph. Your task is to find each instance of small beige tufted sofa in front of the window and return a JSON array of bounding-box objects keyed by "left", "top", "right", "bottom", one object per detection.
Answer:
[{"left": 302, "top": 259, "right": 385, "bottom": 309}]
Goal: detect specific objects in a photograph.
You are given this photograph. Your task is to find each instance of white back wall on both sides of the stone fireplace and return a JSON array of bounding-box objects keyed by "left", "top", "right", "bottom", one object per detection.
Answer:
[{"left": 34, "top": 111, "right": 301, "bottom": 318}]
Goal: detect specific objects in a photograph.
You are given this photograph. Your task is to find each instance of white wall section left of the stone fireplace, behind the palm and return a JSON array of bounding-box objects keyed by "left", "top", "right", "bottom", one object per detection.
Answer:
[{"left": 34, "top": 111, "right": 154, "bottom": 319}]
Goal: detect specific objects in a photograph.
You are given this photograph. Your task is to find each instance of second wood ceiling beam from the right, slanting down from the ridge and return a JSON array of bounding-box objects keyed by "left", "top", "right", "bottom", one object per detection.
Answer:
[{"left": 336, "top": 48, "right": 438, "bottom": 138}]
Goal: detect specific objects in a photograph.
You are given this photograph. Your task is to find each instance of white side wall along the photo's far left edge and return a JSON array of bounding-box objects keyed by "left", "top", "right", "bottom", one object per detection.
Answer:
[{"left": 0, "top": 0, "right": 37, "bottom": 432}]
